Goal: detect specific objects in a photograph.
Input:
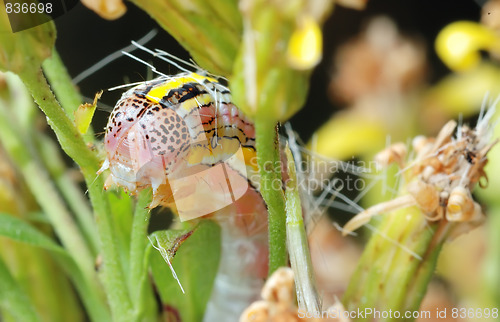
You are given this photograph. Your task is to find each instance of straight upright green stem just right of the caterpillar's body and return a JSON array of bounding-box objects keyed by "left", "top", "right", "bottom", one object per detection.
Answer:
[{"left": 255, "top": 119, "right": 288, "bottom": 275}]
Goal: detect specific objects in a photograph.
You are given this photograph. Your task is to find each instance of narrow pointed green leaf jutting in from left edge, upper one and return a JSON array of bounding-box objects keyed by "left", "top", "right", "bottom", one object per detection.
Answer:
[{"left": 0, "top": 213, "right": 66, "bottom": 254}]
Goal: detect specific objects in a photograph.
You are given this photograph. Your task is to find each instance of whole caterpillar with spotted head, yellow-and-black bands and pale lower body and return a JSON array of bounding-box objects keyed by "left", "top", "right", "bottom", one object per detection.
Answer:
[{"left": 100, "top": 72, "right": 267, "bottom": 321}]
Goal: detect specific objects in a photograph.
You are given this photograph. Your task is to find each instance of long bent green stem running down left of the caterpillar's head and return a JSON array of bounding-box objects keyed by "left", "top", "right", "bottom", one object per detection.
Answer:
[{"left": 20, "top": 70, "right": 132, "bottom": 321}]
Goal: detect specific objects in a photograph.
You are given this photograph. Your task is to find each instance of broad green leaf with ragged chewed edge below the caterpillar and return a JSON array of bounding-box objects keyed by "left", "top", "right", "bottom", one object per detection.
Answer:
[{"left": 151, "top": 220, "right": 220, "bottom": 321}]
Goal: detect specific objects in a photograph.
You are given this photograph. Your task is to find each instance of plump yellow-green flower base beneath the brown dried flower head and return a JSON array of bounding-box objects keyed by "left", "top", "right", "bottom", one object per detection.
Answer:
[{"left": 343, "top": 207, "right": 447, "bottom": 321}]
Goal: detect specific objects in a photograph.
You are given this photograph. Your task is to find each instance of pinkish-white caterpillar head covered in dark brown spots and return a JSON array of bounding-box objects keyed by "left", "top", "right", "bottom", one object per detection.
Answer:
[{"left": 99, "top": 90, "right": 191, "bottom": 200}]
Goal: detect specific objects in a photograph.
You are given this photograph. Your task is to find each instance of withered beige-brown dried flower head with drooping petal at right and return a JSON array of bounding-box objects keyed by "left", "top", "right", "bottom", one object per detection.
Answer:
[{"left": 344, "top": 102, "right": 497, "bottom": 234}]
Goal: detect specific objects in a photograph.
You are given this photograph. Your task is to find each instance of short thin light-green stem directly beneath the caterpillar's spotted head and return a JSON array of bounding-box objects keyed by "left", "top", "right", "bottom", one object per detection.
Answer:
[{"left": 128, "top": 189, "right": 152, "bottom": 318}]
